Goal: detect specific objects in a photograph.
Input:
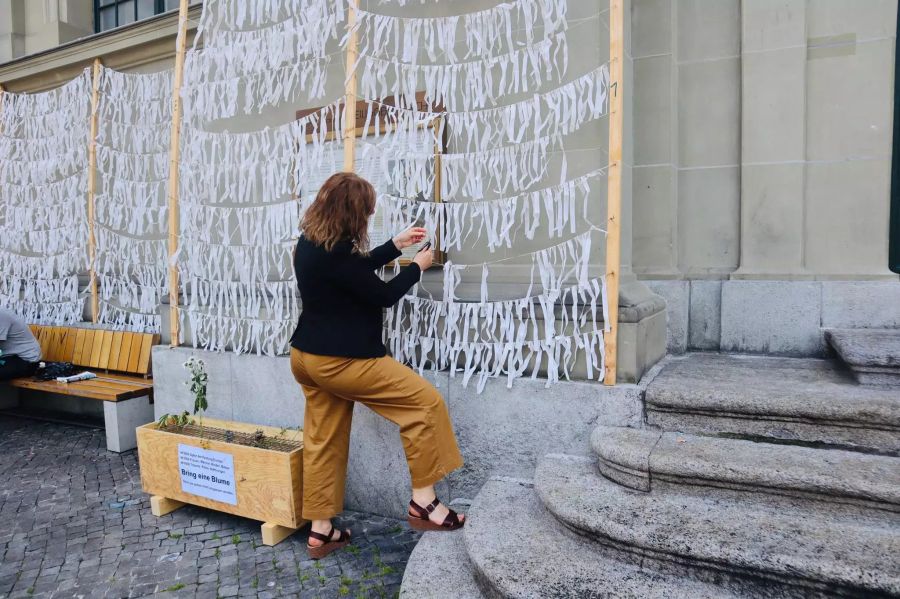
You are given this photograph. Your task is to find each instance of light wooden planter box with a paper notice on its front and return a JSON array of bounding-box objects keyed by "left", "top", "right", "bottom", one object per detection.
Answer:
[{"left": 137, "top": 418, "right": 305, "bottom": 545}]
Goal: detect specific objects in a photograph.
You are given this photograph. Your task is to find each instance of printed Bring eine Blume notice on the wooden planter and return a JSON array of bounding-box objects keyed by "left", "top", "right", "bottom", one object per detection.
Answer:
[{"left": 178, "top": 443, "right": 237, "bottom": 505}]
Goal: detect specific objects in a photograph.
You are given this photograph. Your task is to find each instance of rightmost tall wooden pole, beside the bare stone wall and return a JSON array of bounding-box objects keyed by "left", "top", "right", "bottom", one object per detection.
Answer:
[{"left": 603, "top": 0, "right": 625, "bottom": 385}]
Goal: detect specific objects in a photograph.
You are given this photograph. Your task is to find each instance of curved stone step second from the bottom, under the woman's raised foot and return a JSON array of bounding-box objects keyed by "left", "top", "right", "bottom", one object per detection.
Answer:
[{"left": 460, "top": 478, "right": 744, "bottom": 599}]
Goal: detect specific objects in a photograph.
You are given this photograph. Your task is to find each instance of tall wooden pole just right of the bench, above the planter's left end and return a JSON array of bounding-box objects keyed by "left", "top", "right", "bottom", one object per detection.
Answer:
[{"left": 168, "top": 0, "right": 188, "bottom": 347}]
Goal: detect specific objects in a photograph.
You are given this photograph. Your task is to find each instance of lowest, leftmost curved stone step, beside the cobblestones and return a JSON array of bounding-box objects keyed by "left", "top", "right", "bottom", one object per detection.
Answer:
[{"left": 400, "top": 531, "right": 484, "bottom": 599}]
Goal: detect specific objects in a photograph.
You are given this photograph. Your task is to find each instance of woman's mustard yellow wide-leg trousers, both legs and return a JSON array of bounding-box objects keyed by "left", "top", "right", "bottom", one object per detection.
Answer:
[{"left": 291, "top": 349, "right": 463, "bottom": 520}]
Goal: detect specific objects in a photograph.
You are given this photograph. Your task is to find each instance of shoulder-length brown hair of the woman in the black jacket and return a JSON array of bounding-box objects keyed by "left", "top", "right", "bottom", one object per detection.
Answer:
[{"left": 300, "top": 173, "right": 375, "bottom": 253}]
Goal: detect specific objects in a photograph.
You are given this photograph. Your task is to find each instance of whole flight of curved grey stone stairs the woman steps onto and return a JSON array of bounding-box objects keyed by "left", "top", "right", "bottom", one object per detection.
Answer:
[{"left": 401, "top": 355, "right": 900, "bottom": 599}]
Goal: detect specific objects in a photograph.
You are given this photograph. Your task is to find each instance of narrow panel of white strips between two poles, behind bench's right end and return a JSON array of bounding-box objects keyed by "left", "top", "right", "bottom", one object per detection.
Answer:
[{"left": 94, "top": 68, "right": 172, "bottom": 333}]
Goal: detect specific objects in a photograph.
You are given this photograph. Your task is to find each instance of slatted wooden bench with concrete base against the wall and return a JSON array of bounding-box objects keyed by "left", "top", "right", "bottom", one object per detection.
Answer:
[{"left": 0, "top": 325, "right": 159, "bottom": 452}]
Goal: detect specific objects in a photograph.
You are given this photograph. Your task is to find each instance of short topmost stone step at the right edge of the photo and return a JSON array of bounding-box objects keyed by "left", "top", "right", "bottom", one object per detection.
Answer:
[{"left": 825, "top": 329, "right": 900, "bottom": 386}]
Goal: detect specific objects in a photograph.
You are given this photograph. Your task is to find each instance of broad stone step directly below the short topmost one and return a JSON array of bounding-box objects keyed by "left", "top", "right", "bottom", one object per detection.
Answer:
[{"left": 645, "top": 354, "right": 900, "bottom": 455}]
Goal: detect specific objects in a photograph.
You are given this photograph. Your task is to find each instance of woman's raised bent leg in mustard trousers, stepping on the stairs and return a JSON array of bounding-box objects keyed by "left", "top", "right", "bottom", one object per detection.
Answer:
[{"left": 304, "top": 354, "right": 463, "bottom": 520}]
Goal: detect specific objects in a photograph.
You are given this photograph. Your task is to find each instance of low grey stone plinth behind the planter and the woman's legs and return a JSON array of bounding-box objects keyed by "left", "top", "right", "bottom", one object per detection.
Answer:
[{"left": 153, "top": 346, "right": 644, "bottom": 517}]
